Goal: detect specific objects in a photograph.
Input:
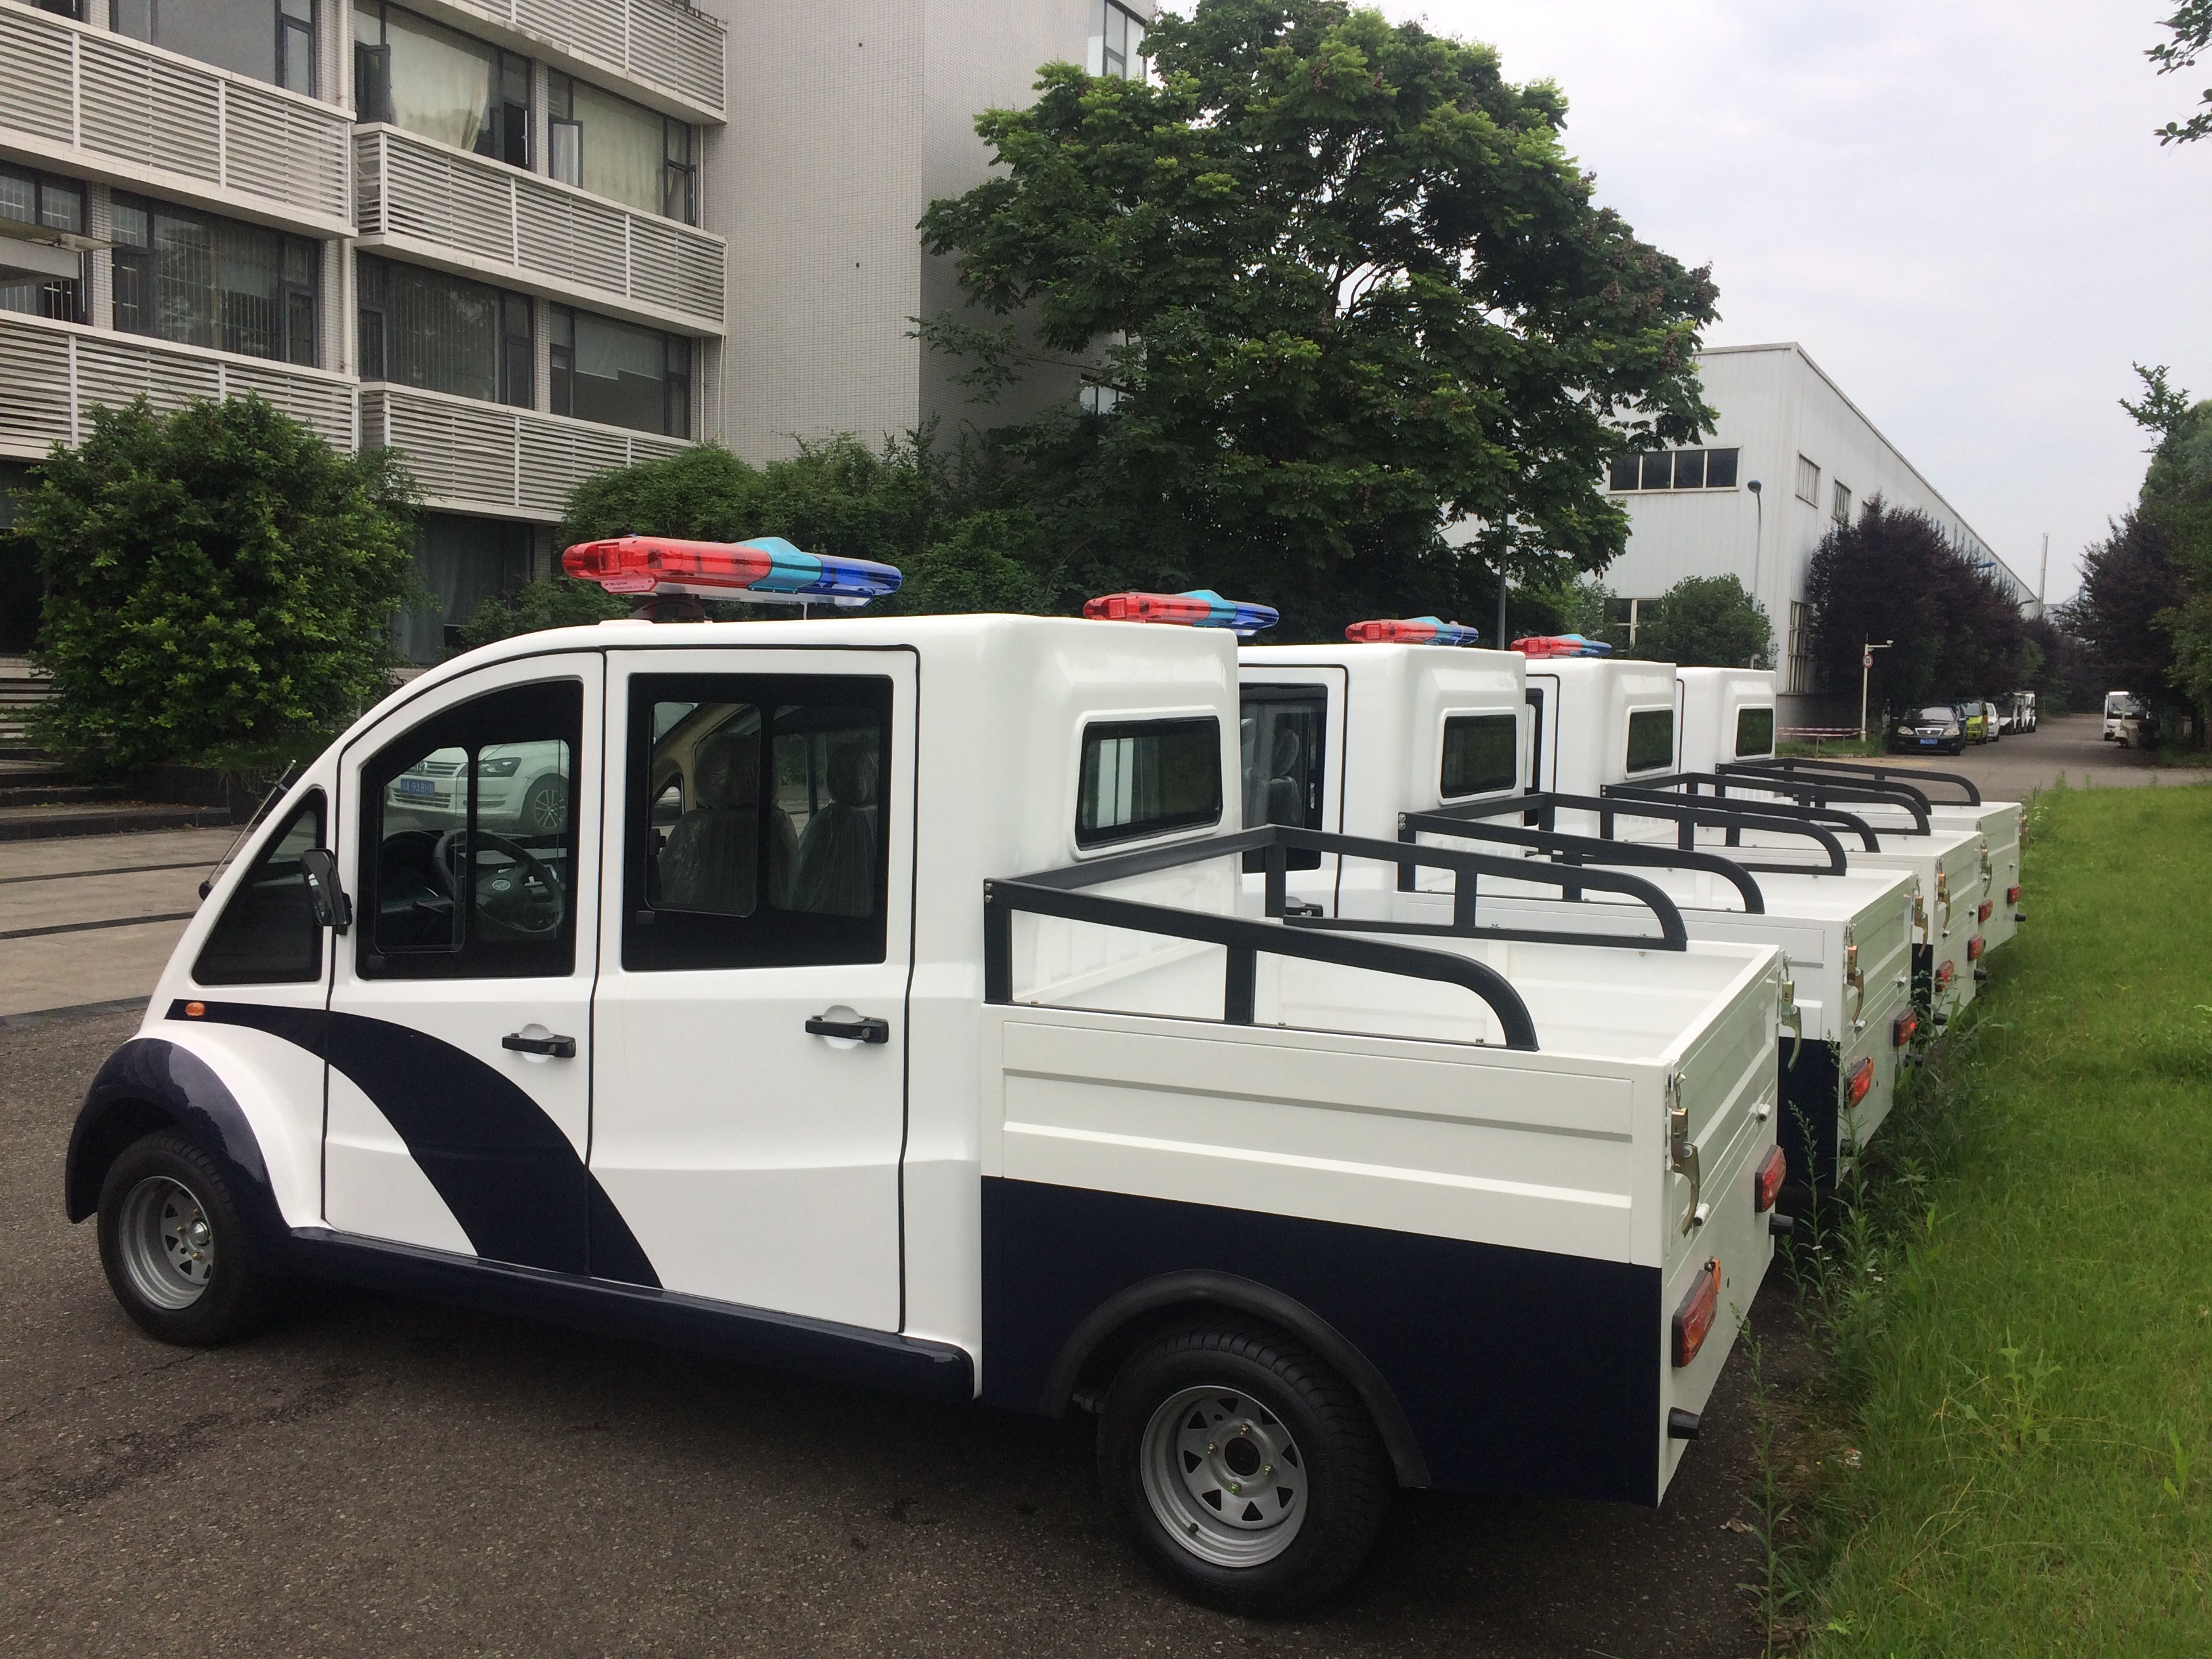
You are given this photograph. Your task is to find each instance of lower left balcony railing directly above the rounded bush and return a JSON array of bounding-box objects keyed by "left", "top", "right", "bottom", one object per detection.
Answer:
[{"left": 0, "top": 312, "right": 356, "bottom": 455}]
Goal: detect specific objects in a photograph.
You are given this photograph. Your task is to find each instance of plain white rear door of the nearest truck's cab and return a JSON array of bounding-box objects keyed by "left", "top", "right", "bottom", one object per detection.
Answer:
[{"left": 590, "top": 648, "right": 916, "bottom": 1330}]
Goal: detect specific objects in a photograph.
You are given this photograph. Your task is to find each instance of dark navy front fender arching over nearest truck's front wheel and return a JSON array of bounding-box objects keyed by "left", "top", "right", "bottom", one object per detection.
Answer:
[{"left": 62, "top": 1038, "right": 290, "bottom": 1241}]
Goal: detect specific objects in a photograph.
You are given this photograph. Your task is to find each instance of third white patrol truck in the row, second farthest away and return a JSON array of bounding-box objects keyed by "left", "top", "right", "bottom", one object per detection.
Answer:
[{"left": 1528, "top": 657, "right": 1986, "bottom": 1026}]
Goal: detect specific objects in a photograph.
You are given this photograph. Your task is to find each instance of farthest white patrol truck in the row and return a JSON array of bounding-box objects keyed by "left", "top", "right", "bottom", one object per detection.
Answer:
[{"left": 1675, "top": 668, "right": 2022, "bottom": 960}]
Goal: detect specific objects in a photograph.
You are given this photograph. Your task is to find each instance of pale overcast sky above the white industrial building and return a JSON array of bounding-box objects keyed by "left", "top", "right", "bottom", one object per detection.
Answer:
[{"left": 1382, "top": 0, "right": 2212, "bottom": 604}]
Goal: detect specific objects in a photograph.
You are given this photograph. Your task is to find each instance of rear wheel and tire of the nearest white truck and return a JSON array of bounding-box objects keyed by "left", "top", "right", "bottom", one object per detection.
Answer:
[{"left": 1097, "top": 1327, "right": 1396, "bottom": 1619}]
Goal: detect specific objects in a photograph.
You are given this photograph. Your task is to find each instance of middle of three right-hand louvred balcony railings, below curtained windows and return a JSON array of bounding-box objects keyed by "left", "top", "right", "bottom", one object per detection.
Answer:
[{"left": 354, "top": 126, "right": 726, "bottom": 334}]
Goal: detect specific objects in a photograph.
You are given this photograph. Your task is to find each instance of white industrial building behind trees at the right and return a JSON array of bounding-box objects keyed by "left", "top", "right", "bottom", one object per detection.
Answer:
[{"left": 1603, "top": 345, "right": 2035, "bottom": 723}]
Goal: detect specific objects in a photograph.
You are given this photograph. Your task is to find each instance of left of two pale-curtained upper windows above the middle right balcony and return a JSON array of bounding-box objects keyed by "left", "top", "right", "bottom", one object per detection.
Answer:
[{"left": 354, "top": 0, "right": 531, "bottom": 168}]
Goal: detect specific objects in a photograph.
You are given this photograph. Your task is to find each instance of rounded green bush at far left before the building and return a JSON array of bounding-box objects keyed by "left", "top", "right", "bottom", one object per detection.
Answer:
[{"left": 18, "top": 398, "right": 418, "bottom": 772}]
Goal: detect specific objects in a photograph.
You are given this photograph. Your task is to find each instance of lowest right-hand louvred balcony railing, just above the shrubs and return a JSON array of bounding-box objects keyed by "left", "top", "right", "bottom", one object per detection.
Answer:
[{"left": 361, "top": 385, "right": 688, "bottom": 520}]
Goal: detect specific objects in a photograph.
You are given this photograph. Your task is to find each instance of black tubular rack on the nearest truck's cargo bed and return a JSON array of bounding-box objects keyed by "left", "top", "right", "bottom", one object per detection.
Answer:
[{"left": 982, "top": 825, "right": 1690, "bottom": 1050}]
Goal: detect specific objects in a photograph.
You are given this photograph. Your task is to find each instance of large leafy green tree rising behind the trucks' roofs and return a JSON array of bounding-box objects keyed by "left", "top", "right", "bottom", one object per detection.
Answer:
[{"left": 922, "top": 0, "right": 1715, "bottom": 637}]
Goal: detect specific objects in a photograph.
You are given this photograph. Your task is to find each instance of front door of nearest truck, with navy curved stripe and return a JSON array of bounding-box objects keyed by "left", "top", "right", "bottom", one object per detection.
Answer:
[{"left": 323, "top": 653, "right": 619, "bottom": 1279}]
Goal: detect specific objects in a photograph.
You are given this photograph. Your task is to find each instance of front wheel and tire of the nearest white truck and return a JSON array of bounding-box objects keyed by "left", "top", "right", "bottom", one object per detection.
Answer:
[{"left": 98, "top": 1130, "right": 283, "bottom": 1347}]
